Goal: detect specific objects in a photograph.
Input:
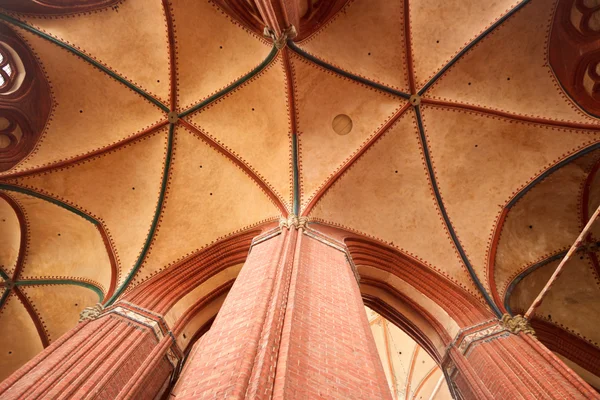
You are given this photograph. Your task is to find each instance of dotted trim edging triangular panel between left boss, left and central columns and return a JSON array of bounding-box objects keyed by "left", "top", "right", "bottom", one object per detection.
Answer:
[{"left": 129, "top": 126, "right": 279, "bottom": 288}]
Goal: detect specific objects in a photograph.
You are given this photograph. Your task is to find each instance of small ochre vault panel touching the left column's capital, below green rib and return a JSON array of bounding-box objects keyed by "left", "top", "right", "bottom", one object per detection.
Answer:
[{"left": 21, "top": 285, "right": 100, "bottom": 343}]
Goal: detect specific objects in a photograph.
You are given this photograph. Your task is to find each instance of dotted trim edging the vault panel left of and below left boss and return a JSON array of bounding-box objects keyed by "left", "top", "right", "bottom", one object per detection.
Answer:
[{"left": 10, "top": 128, "right": 167, "bottom": 283}]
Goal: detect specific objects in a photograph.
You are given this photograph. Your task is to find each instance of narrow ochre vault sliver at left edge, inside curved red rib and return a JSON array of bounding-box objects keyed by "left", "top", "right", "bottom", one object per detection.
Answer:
[{"left": 0, "top": 192, "right": 21, "bottom": 278}]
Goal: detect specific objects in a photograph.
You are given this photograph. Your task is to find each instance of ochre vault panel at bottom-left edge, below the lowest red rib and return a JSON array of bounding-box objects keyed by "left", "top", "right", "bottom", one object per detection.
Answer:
[{"left": 0, "top": 293, "right": 44, "bottom": 381}]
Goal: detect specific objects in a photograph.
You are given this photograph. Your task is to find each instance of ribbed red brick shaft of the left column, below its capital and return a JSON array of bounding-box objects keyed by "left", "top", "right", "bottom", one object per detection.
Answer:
[{"left": 0, "top": 314, "right": 173, "bottom": 400}]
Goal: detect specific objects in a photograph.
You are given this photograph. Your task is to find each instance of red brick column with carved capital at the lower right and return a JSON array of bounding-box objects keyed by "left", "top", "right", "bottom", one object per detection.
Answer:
[{"left": 443, "top": 320, "right": 600, "bottom": 400}]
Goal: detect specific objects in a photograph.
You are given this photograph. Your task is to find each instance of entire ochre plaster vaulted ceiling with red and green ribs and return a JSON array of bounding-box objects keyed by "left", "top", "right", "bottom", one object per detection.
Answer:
[{"left": 0, "top": 0, "right": 600, "bottom": 384}]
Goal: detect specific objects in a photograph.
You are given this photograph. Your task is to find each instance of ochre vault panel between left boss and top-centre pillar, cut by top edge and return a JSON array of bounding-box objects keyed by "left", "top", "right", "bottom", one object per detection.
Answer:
[{"left": 169, "top": 0, "right": 271, "bottom": 110}]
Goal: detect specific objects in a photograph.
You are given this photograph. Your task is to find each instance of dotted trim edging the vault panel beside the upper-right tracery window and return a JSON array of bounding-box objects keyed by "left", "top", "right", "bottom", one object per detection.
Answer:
[{"left": 428, "top": 2, "right": 600, "bottom": 124}]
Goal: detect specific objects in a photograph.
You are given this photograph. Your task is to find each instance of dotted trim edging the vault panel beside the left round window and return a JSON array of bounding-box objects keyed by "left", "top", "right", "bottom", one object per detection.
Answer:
[{"left": 0, "top": 24, "right": 164, "bottom": 177}]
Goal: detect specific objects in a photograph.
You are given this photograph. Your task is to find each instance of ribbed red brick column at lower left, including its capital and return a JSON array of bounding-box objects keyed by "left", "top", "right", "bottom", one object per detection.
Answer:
[{"left": 0, "top": 302, "right": 181, "bottom": 400}]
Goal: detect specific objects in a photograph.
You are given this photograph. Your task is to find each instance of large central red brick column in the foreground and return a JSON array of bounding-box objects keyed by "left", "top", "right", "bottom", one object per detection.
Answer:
[{"left": 171, "top": 222, "right": 391, "bottom": 400}]
